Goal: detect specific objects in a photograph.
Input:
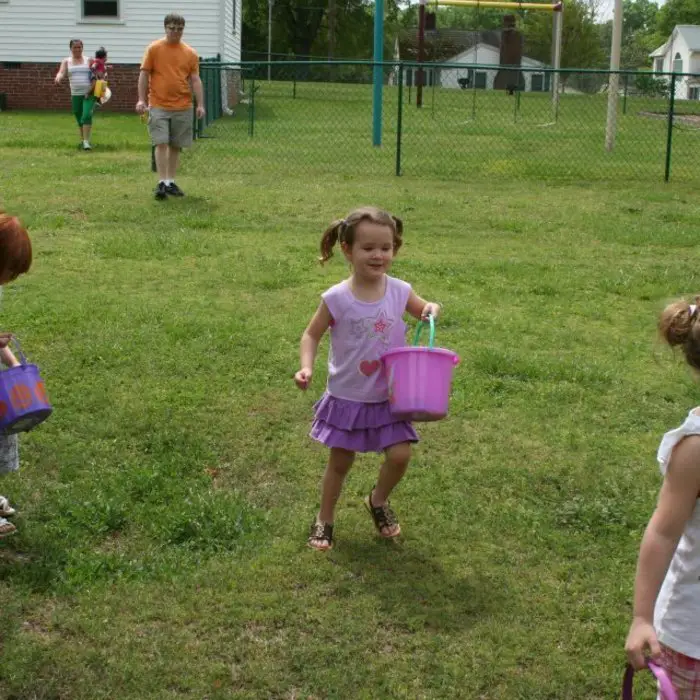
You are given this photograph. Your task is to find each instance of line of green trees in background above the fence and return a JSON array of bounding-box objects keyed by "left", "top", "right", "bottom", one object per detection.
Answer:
[{"left": 242, "top": 0, "right": 700, "bottom": 69}]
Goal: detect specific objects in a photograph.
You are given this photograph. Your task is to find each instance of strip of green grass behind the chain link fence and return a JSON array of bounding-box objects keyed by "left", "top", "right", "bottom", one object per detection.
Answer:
[{"left": 194, "top": 75, "right": 700, "bottom": 185}]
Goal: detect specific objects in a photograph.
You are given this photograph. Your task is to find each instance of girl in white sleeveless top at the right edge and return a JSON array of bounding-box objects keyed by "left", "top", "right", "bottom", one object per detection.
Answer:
[{"left": 625, "top": 297, "right": 700, "bottom": 700}]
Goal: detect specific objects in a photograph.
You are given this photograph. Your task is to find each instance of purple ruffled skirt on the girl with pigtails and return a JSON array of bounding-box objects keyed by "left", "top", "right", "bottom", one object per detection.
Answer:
[{"left": 309, "top": 392, "right": 418, "bottom": 452}]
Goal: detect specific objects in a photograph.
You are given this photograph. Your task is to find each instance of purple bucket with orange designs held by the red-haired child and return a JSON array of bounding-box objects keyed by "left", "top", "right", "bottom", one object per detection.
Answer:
[{"left": 0, "top": 339, "right": 53, "bottom": 435}]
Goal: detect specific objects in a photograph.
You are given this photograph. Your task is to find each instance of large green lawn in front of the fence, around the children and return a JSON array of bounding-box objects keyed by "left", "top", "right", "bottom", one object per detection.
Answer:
[{"left": 0, "top": 105, "right": 700, "bottom": 700}]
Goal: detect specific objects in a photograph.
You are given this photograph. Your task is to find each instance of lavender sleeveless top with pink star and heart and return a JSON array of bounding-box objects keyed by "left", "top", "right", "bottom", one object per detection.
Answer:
[{"left": 321, "top": 275, "right": 411, "bottom": 403}]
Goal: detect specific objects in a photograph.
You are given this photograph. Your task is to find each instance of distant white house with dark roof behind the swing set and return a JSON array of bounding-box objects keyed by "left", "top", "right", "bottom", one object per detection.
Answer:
[{"left": 395, "top": 30, "right": 550, "bottom": 92}]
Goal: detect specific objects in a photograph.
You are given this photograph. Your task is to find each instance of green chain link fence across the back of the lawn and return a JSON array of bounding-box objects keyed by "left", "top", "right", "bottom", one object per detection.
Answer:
[{"left": 190, "top": 61, "right": 700, "bottom": 184}]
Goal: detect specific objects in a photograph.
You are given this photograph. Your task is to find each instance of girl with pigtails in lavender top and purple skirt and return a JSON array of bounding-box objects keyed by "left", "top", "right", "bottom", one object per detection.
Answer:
[{"left": 294, "top": 207, "right": 440, "bottom": 550}]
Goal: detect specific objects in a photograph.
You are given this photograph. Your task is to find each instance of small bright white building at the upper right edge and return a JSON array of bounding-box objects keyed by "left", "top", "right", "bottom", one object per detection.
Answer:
[{"left": 649, "top": 24, "right": 700, "bottom": 100}]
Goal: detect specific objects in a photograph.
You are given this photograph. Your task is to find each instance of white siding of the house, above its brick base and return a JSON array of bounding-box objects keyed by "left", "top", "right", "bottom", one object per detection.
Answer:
[{"left": 0, "top": 0, "right": 241, "bottom": 68}]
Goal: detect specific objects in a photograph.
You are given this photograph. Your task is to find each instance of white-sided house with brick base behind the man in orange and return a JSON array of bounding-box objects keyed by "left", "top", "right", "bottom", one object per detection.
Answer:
[{"left": 0, "top": 0, "right": 242, "bottom": 109}]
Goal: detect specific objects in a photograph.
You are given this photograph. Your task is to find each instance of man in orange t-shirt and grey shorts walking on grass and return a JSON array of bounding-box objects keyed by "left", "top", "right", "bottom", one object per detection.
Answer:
[{"left": 136, "top": 13, "right": 204, "bottom": 199}]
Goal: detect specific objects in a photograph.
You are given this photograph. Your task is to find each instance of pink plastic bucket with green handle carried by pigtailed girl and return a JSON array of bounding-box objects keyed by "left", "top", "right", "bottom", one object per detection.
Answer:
[{"left": 382, "top": 317, "right": 459, "bottom": 421}]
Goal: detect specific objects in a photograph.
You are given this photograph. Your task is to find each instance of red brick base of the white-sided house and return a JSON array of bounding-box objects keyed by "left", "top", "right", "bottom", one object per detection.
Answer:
[{"left": 0, "top": 62, "right": 139, "bottom": 112}]
